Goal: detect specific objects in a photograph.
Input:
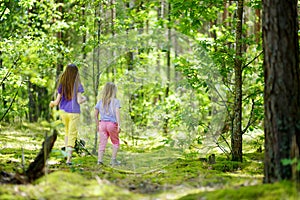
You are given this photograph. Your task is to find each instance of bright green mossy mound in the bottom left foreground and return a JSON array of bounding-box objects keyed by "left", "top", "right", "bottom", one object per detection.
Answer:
[{"left": 0, "top": 171, "right": 141, "bottom": 200}]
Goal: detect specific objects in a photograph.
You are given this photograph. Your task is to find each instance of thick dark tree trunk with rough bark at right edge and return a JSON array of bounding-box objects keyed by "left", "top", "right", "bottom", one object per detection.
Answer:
[{"left": 263, "top": 0, "right": 300, "bottom": 183}]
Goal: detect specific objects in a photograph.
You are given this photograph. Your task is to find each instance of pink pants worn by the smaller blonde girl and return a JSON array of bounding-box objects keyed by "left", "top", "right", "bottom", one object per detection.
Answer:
[{"left": 99, "top": 121, "right": 120, "bottom": 151}]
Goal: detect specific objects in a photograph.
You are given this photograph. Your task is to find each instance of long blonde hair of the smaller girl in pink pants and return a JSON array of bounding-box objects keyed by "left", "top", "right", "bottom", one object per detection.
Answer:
[{"left": 102, "top": 82, "right": 117, "bottom": 112}]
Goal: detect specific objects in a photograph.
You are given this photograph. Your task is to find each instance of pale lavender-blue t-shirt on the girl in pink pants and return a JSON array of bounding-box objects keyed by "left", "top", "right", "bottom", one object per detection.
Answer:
[{"left": 95, "top": 99, "right": 121, "bottom": 122}]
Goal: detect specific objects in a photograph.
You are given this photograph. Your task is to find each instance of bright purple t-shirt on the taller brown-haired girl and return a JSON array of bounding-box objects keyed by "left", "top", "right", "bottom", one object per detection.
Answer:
[{"left": 57, "top": 84, "right": 84, "bottom": 113}]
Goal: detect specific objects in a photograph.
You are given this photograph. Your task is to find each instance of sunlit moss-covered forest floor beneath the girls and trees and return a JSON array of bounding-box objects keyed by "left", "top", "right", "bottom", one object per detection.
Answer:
[{"left": 0, "top": 123, "right": 300, "bottom": 200}]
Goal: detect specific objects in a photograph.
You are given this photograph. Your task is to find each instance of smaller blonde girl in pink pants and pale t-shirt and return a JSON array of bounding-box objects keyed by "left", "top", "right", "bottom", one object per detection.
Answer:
[{"left": 95, "top": 82, "right": 121, "bottom": 165}]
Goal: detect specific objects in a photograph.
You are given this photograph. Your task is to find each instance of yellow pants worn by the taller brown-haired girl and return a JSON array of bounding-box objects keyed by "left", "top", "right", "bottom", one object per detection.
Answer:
[{"left": 60, "top": 111, "right": 80, "bottom": 147}]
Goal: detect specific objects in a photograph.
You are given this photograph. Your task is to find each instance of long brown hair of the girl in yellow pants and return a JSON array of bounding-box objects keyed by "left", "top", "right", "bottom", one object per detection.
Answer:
[{"left": 58, "top": 64, "right": 80, "bottom": 100}]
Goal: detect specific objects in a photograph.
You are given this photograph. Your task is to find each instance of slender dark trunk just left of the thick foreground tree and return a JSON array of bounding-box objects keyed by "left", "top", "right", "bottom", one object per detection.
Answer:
[{"left": 231, "top": 0, "right": 244, "bottom": 162}]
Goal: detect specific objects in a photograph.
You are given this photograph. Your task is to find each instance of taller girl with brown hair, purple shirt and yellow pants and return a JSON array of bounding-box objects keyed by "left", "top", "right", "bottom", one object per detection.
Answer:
[{"left": 50, "top": 64, "right": 86, "bottom": 165}]
